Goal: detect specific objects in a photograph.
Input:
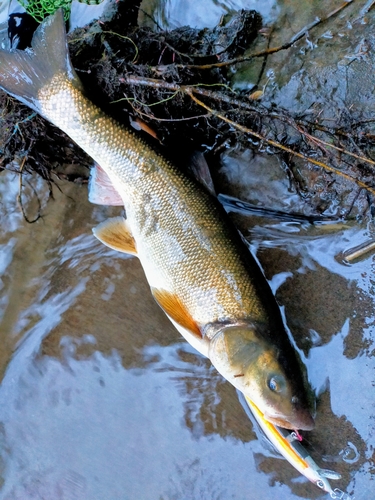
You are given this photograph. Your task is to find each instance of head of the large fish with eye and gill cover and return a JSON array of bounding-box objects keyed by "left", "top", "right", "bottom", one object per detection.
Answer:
[{"left": 209, "top": 325, "right": 314, "bottom": 430}]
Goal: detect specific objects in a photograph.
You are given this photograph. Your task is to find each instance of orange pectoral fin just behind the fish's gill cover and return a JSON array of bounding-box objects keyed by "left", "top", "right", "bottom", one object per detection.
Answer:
[{"left": 152, "top": 288, "right": 202, "bottom": 338}]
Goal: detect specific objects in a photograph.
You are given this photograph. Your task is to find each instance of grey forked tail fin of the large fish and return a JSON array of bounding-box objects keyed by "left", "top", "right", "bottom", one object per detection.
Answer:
[{"left": 0, "top": 9, "right": 81, "bottom": 113}]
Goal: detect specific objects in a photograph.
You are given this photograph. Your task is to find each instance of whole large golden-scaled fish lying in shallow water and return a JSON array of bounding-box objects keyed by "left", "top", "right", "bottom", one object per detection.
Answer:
[{"left": 0, "top": 10, "right": 314, "bottom": 430}]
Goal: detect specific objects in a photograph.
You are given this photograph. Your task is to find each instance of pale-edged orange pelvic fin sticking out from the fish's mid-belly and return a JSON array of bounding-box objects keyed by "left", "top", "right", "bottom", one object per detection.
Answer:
[{"left": 92, "top": 217, "right": 137, "bottom": 255}]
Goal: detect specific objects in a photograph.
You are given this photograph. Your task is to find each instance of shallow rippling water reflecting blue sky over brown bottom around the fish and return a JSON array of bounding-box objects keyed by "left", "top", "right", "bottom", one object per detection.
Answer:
[{"left": 0, "top": 2, "right": 375, "bottom": 500}]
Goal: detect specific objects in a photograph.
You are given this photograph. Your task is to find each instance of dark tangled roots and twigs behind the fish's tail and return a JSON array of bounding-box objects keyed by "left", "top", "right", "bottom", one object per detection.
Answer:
[{"left": 0, "top": 1, "right": 375, "bottom": 217}]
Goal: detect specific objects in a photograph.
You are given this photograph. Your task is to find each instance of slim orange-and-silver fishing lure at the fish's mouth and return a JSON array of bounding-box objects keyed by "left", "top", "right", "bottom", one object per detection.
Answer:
[{"left": 244, "top": 396, "right": 351, "bottom": 500}]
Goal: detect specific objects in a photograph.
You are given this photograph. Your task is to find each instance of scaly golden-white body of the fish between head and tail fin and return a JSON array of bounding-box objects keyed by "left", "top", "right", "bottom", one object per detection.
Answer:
[{"left": 38, "top": 75, "right": 267, "bottom": 325}]
